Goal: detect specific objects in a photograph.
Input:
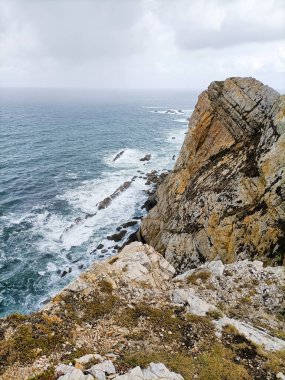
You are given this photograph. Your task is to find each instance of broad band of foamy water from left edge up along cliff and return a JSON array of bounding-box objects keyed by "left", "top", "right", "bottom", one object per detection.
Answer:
[{"left": 0, "top": 100, "right": 191, "bottom": 311}]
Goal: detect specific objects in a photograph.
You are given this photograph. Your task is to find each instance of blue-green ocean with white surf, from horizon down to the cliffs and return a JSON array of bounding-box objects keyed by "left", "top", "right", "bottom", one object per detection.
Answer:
[{"left": 0, "top": 89, "right": 198, "bottom": 316}]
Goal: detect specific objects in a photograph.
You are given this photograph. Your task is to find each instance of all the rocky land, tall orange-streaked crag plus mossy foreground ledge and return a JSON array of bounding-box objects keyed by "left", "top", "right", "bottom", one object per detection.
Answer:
[{"left": 0, "top": 78, "right": 285, "bottom": 380}]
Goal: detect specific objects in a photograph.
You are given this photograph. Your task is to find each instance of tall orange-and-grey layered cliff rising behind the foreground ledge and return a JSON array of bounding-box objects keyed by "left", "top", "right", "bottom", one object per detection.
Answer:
[{"left": 141, "top": 78, "right": 285, "bottom": 270}]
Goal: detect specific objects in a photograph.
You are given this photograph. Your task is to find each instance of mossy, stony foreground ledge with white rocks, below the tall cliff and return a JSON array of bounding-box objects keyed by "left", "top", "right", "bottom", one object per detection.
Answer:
[{"left": 0, "top": 242, "right": 285, "bottom": 380}]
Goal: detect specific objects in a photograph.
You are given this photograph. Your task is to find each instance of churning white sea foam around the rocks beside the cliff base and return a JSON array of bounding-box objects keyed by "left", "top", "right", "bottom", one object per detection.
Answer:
[{"left": 1, "top": 101, "right": 191, "bottom": 314}]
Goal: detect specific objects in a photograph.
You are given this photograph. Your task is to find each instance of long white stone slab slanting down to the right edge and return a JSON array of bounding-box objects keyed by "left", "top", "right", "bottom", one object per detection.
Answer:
[{"left": 214, "top": 317, "right": 285, "bottom": 351}]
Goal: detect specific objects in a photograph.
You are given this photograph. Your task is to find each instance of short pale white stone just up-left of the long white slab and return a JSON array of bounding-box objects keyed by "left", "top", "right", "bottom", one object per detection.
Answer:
[{"left": 172, "top": 289, "right": 217, "bottom": 316}]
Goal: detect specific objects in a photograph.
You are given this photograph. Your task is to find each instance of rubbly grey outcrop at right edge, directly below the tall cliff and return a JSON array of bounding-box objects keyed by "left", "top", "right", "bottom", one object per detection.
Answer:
[{"left": 173, "top": 260, "right": 285, "bottom": 321}]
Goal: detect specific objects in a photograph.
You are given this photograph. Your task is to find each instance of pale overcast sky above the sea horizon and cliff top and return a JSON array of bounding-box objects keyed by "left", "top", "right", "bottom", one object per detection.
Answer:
[{"left": 0, "top": 0, "right": 285, "bottom": 89}]
